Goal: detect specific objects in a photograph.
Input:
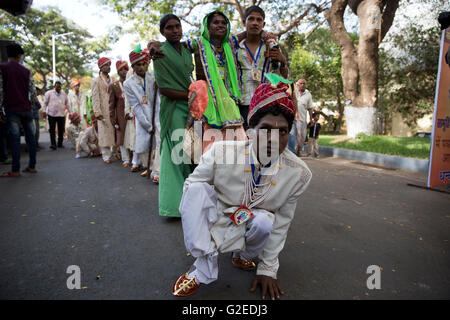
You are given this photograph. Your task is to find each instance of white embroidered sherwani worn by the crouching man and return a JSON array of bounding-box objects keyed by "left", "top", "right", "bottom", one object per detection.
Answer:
[{"left": 180, "top": 141, "right": 312, "bottom": 279}]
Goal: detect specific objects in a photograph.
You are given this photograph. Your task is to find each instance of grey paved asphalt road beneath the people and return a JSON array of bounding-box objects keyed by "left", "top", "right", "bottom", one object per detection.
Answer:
[{"left": 0, "top": 133, "right": 450, "bottom": 299}]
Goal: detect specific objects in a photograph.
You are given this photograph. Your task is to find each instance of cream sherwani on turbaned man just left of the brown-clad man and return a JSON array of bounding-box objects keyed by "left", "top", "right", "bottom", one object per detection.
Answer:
[{"left": 91, "top": 76, "right": 115, "bottom": 147}]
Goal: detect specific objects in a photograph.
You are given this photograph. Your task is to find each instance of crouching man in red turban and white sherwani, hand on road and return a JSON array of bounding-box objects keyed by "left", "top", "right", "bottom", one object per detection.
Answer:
[{"left": 172, "top": 82, "right": 311, "bottom": 299}]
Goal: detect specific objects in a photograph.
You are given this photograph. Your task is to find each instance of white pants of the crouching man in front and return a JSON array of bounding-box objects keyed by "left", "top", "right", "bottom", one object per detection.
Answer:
[{"left": 180, "top": 182, "right": 273, "bottom": 284}]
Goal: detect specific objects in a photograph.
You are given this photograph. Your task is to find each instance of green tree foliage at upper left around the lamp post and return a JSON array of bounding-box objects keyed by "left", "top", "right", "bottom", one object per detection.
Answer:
[{"left": 0, "top": 7, "right": 116, "bottom": 88}]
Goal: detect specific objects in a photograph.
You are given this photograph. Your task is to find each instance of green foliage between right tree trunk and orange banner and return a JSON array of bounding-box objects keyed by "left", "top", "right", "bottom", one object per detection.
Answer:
[{"left": 379, "top": 21, "right": 441, "bottom": 127}]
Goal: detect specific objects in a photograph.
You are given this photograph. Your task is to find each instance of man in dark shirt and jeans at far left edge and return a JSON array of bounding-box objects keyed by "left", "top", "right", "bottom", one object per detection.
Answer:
[{"left": 0, "top": 43, "right": 37, "bottom": 177}]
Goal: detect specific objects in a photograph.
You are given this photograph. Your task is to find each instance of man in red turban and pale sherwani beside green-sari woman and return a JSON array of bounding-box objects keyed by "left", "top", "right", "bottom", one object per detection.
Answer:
[{"left": 123, "top": 46, "right": 159, "bottom": 176}]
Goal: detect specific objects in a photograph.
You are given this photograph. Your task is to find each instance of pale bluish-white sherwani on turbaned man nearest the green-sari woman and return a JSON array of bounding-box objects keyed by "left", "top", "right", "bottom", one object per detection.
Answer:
[{"left": 123, "top": 72, "right": 160, "bottom": 153}]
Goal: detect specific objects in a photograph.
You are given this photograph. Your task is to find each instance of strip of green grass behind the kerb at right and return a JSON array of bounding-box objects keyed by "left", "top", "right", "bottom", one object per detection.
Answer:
[{"left": 319, "top": 135, "right": 430, "bottom": 159}]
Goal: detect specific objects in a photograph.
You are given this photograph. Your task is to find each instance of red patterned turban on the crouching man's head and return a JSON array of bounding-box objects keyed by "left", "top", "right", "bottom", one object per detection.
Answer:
[{"left": 247, "top": 82, "right": 295, "bottom": 124}]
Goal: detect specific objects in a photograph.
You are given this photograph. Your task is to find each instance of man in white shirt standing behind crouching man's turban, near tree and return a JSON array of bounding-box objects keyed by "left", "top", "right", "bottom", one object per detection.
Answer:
[{"left": 291, "top": 78, "right": 313, "bottom": 156}]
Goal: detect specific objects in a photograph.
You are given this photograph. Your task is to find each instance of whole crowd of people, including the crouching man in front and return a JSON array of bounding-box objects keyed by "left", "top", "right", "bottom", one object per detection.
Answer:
[{"left": 0, "top": 6, "right": 320, "bottom": 299}]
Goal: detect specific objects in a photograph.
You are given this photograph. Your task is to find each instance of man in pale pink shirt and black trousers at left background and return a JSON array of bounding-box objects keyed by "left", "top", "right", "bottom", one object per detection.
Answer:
[{"left": 42, "top": 81, "right": 69, "bottom": 150}]
